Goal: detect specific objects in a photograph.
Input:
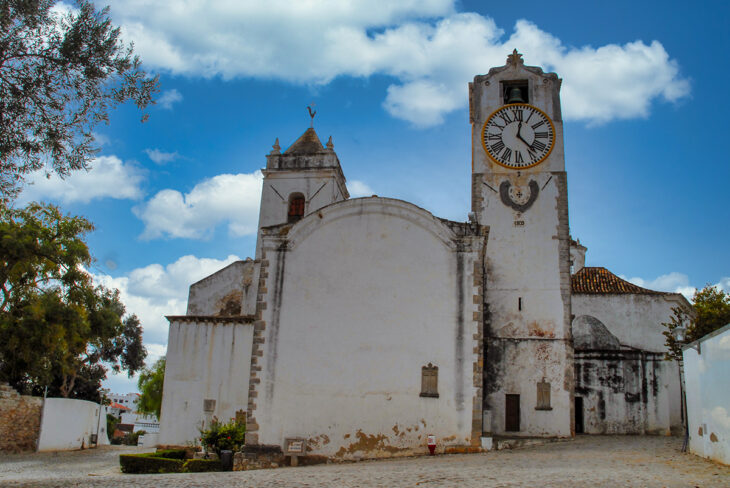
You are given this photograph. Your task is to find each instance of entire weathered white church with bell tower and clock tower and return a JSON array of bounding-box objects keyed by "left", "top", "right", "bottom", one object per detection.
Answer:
[{"left": 159, "top": 51, "right": 689, "bottom": 459}]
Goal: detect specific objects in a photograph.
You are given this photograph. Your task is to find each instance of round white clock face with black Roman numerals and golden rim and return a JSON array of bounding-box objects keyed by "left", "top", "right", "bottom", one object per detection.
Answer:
[{"left": 482, "top": 103, "right": 555, "bottom": 169}]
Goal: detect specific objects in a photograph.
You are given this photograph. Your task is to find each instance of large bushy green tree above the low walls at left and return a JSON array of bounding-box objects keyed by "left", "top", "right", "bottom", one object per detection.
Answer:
[{"left": 0, "top": 203, "right": 147, "bottom": 401}]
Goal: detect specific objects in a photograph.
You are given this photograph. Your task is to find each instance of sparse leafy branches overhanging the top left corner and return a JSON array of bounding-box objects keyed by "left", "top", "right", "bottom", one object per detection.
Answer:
[{"left": 0, "top": 0, "right": 158, "bottom": 201}]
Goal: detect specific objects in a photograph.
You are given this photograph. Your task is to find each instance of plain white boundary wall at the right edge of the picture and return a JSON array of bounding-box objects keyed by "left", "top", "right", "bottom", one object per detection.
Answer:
[{"left": 683, "top": 325, "right": 730, "bottom": 465}]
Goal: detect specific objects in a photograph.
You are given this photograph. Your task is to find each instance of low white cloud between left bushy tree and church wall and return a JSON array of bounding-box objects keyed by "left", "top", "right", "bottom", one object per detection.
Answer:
[{"left": 92, "top": 255, "right": 239, "bottom": 393}]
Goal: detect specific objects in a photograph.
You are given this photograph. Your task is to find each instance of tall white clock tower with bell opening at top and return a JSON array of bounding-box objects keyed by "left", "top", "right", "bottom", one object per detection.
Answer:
[{"left": 469, "top": 50, "right": 574, "bottom": 436}]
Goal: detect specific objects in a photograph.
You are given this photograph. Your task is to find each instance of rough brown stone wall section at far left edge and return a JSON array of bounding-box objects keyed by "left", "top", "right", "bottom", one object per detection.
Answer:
[{"left": 0, "top": 383, "right": 43, "bottom": 452}]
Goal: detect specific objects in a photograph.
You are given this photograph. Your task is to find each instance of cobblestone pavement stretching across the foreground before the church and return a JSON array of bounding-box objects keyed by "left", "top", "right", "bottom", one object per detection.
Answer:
[{"left": 0, "top": 436, "right": 730, "bottom": 488}]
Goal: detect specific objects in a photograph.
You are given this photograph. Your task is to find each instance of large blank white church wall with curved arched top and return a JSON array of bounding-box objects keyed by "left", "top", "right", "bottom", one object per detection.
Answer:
[{"left": 247, "top": 198, "right": 484, "bottom": 459}]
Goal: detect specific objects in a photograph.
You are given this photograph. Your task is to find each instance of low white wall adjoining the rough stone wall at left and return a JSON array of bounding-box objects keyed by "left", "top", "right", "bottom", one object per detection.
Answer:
[{"left": 37, "top": 398, "right": 109, "bottom": 451}]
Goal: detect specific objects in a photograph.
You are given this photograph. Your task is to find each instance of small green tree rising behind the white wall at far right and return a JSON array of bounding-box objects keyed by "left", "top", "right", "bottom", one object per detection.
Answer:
[{"left": 662, "top": 284, "right": 730, "bottom": 361}]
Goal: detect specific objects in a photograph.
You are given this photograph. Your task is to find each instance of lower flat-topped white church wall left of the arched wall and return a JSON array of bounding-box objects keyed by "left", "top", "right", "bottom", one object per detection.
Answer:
[{"left": 159, "top": 316, "right": 253, "bottom": 445}]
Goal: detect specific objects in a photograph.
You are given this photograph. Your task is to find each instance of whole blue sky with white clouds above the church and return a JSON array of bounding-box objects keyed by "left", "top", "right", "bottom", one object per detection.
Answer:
[{"left": 18, "top": 0, "right": 730, "bottom": 393}]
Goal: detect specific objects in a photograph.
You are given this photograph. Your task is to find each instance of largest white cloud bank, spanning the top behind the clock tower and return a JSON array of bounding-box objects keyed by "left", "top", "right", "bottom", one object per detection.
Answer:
[{"left": 105, "top": 0, "right": 690, "bottom": 127}]
